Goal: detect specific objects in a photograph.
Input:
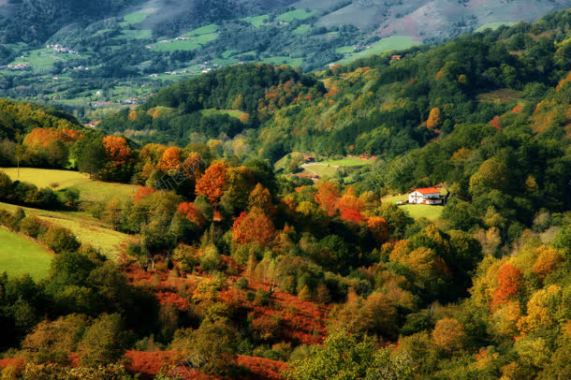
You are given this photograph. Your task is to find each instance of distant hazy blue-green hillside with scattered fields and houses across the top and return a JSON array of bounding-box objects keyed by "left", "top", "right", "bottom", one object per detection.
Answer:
[{"left": 0, "top": 0, "right": 571, "bottom": 119}]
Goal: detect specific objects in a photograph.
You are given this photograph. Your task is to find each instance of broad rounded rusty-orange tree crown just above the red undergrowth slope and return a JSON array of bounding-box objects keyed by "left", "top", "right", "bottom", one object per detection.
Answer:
[{"left": 232, "top": 207, "right": 276, "bottom": 246}]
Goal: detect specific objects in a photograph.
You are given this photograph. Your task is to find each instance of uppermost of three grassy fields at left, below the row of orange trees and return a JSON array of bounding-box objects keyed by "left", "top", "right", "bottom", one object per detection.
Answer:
[{"left": 0, "top": 168, "right": 139, "bottom": 202}]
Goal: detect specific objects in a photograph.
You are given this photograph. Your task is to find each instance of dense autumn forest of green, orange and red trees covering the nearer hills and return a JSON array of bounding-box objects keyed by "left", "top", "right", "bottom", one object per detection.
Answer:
[{"left": 0, "top": 8, "right": 571, "bottom": 380}]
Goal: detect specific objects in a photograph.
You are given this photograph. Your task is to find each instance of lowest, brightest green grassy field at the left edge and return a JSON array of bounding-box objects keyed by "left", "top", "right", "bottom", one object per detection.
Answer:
[{"left": 0, "top": 228, "right": 52, "bottom": 280}]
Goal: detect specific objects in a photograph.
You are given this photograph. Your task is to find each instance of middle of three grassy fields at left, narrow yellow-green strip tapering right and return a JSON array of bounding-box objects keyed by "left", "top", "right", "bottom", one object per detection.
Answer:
[{"left": 0, "top": 203, "right": 136, "bottom": 260}]
